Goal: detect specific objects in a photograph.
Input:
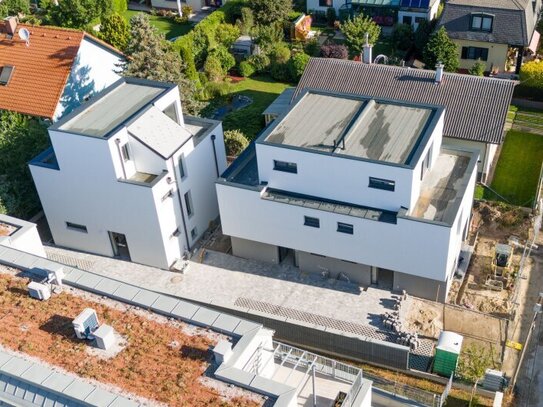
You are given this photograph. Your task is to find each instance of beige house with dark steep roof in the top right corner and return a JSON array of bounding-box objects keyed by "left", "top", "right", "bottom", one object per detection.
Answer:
[{"left": 439, "top": 0, "right": 541, "bottom": 74}]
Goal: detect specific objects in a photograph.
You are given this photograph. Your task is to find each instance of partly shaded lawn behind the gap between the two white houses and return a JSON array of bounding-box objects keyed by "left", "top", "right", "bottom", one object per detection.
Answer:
[{"left": 218, "top": 76, "right": 292, "bottom": 140}]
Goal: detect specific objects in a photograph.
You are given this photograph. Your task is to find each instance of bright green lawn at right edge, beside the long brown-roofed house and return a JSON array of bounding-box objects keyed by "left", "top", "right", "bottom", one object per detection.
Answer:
[{"left": 491, "top": 130, "right": 543, "bottom": 206}]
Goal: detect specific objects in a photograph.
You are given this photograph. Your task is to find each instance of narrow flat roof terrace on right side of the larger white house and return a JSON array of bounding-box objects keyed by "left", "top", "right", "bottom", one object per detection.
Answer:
[{"left": 409, "top": 149, "right": 477, "bottom": 224}]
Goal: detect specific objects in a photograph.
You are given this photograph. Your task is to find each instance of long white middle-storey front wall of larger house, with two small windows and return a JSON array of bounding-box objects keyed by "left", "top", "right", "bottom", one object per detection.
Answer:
[{"left": 217, "top": 184, "right": 451, "bottom": 281}]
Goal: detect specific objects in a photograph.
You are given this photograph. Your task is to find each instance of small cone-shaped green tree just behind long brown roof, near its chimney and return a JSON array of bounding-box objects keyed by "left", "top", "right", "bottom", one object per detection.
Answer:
[{"left": 422, "top": 27, "right": 459, "bottom": 72}]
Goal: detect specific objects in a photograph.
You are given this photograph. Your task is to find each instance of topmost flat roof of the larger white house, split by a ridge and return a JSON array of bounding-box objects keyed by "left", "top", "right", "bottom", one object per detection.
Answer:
[{"left": 262, "top": 91, "right": 438, "bottom": 165}]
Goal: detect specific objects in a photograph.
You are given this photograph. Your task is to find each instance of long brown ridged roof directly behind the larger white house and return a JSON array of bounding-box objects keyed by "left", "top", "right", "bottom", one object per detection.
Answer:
[{"left": 294, "top": 58, "right": 515, "bottom": 144}]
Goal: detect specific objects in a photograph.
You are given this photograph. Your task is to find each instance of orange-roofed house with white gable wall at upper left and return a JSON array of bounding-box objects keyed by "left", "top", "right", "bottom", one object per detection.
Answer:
[{"left": 0, "top": 17, "right": 124, "bottom": 121}]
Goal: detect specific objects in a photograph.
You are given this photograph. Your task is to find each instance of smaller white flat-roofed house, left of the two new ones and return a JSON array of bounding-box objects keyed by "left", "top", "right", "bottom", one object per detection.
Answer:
[{"left": 30, "top": 78, "right": 226, "bottom": 269}]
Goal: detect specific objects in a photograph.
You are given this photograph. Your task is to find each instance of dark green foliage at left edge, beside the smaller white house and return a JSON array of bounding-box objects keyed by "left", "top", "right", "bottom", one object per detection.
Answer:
[{"left": 0, "top": 110, "right": 49, "bottom": 218}]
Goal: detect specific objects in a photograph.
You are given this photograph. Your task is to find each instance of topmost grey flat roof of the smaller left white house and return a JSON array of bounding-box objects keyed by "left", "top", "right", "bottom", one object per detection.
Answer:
[{"left": 52, "top": 78, "right": 171, "bottom": 138}]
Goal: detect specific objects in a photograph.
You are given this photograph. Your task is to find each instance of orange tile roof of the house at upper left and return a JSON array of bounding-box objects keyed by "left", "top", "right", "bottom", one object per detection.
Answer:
[{"left": 0, "top": 22, "right": 121, "bottom": 118}]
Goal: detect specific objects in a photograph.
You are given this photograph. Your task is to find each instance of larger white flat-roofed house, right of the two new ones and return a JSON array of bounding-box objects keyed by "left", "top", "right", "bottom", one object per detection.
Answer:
[{"left": 217, "top": 85, "right": 479, "bottom": 301}]
